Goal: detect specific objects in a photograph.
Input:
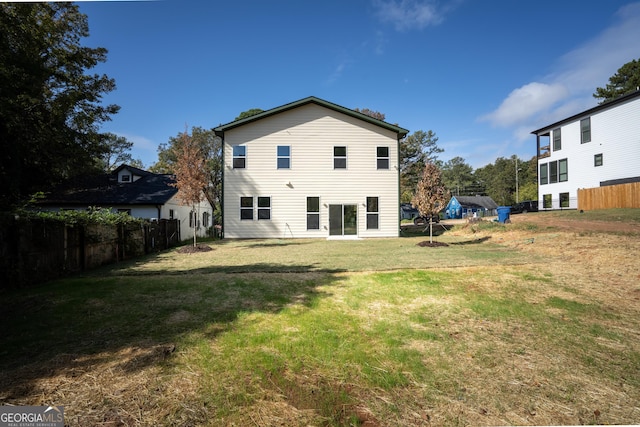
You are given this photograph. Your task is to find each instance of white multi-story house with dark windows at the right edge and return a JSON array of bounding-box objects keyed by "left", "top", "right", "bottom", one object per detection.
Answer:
[{"left": 532, "top": 91, "right": 640, "bottom": 210}]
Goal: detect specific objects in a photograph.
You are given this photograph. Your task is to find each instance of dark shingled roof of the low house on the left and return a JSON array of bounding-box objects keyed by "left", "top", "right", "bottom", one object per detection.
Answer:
[{"left": 40, "top": 165, "right": 178, "bottom": 206}]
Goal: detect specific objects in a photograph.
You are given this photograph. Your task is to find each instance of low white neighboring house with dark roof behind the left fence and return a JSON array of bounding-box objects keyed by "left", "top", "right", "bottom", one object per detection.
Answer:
[{"left": 38, "top": 165, "right": 213, "bottom": 240}]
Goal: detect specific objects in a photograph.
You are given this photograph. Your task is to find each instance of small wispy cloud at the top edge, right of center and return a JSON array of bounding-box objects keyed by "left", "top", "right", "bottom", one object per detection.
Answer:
[{"left": 373, "top": 0, "right": 444, "bottom": 31}]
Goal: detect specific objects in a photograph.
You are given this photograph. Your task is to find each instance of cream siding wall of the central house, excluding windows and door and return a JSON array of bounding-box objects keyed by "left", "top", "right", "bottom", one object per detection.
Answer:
[{"left": 224, "top": 104, "right": 399, "bottom": 238}]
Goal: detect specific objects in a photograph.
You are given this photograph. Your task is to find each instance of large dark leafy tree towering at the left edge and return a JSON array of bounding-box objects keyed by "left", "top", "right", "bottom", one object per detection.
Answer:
[{"left": 0, "top": 2, "right": 119, "bottom": 208}]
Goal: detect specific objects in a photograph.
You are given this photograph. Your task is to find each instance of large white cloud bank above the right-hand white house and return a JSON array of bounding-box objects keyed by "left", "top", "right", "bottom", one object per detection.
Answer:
[{"left": 479, "top": 3, "right": 640, "bottom": 140}]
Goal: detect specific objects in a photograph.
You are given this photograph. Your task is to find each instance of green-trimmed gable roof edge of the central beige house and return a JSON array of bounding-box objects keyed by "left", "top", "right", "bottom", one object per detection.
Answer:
[{"left": 214, "top": 96, "right": 409, "bottom": 139}]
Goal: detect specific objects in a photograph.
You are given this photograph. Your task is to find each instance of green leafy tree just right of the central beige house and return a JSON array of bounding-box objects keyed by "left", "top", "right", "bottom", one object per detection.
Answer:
[{"left": 399, "top": 130, "right": 444, "bottom": 202}]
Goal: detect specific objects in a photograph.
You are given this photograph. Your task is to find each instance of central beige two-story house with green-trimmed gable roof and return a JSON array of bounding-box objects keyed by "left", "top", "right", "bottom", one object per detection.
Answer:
[{"left": 214, "top": 97, "right": 408, "bottom": 238}]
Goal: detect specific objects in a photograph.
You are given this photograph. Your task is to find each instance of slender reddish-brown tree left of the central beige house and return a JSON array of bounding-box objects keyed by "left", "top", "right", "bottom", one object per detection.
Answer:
[{"left": 173, "top": 129, "right": 208, "bottom": 246}]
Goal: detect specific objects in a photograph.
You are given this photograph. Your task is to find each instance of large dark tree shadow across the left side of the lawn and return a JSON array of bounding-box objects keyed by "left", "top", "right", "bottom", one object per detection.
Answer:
[{"left": 0, "top": 259, "right": 338, "bottom": 404}]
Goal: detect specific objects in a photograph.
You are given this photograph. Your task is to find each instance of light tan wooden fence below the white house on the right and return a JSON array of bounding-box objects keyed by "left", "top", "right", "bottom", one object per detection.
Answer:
[{"left": 578, "top": 182, "right": 640, "bottom": 211}]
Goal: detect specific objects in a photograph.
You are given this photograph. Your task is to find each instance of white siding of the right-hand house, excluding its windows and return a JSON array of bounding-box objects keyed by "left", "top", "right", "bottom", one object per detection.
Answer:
[{"left": 538, "top": 98, "right": 640, "bottom": 209}]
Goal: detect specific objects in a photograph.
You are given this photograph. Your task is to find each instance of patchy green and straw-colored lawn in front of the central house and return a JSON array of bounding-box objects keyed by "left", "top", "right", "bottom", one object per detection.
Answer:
[{"left": 0, "top": 216, "right": 640, "bottom": 425}]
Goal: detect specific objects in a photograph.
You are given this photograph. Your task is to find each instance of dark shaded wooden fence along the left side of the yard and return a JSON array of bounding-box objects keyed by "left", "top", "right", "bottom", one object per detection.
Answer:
[{"left": 0, "top": 219, "right": 180, "bottom": 288}]
